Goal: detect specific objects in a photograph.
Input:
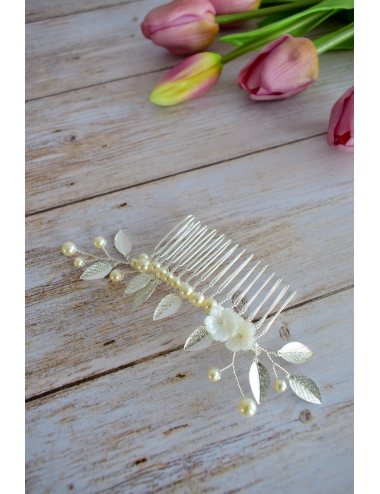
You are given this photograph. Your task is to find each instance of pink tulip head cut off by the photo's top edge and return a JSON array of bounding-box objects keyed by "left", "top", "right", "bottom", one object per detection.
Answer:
[{"left": 141, "top": 0, "right": 219, "bottom": 55}]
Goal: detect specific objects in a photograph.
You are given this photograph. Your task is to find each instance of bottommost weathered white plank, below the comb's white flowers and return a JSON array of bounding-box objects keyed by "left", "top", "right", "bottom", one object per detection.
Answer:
[{"left": 26, "top": 290, "right": 353, "bottom": 494}]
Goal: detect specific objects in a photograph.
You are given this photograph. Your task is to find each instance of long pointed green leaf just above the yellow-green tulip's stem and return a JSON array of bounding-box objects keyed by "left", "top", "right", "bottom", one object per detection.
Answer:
[{"left": 219, "top": 0, "right": 354, "bottom": 46}]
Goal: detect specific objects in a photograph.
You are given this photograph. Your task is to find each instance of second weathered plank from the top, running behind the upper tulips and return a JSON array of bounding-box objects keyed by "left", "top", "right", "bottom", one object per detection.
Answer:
[{"left": 26, "top": 0, "right": 249, "bottom": 100}]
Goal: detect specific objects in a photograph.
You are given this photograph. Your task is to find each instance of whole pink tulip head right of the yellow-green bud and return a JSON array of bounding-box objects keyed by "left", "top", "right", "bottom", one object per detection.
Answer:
[{"left": 238, "top": 34, "right": 319, "bottom": 100}]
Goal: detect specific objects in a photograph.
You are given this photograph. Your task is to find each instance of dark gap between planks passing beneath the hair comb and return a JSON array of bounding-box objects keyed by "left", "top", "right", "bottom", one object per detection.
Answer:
[{"left": 25, "top": 283, "right": 354, "bottom": 403}]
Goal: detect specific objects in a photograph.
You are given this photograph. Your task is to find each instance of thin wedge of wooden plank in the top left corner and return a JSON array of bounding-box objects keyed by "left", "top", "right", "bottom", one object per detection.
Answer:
[{"left": 25, "top": 0, "right": 138, "bottom": 22}]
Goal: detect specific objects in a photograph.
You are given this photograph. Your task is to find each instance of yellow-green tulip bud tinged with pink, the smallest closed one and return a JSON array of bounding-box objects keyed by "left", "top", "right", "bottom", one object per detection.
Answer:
[{"left": 149, "top": 52, "right": 223, "bottom": 106}]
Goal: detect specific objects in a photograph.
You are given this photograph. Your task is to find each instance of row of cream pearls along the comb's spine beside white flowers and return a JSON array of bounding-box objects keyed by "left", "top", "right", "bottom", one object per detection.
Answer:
[{"left": 131, "top": 254, "right": 218, "bottom": 314}]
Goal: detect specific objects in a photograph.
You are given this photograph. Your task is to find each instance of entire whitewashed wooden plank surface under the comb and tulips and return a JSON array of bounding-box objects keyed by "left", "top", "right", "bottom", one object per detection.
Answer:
[{"left": 26, "top": 0, "right": 353, "bottom": 494}]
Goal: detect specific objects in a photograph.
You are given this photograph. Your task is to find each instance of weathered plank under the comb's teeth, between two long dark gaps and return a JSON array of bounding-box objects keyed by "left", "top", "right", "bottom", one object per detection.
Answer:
[{"left": 27, "top": 136, "right": 353, "bottom": 396}]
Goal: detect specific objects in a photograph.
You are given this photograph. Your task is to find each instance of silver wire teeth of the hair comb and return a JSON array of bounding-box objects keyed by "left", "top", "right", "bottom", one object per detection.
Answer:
[{"left": 153, "top": 216, "right": 295, "bottom": 329}]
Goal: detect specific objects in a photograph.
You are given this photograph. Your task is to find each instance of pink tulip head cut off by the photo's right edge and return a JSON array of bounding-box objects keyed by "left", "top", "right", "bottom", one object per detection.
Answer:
[{"left": 327, "top": 86, "right": 354, "bottom": 151}]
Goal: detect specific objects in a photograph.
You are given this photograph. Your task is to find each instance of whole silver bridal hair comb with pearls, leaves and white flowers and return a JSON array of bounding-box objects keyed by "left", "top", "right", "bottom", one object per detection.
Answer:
[{"left": 62, "top": 215, "right": 322, "bottom": 417}]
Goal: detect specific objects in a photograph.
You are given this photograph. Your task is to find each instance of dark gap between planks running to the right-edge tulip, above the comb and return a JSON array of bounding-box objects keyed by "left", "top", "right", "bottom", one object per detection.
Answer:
[{"left": 25, "top": 132, "right": 327, "bottom": 218}]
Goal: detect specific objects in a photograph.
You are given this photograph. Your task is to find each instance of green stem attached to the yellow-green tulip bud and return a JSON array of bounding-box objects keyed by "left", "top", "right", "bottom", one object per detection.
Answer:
[{"left": 221, "top": 10, "right": 336, "bottom": 64}]
